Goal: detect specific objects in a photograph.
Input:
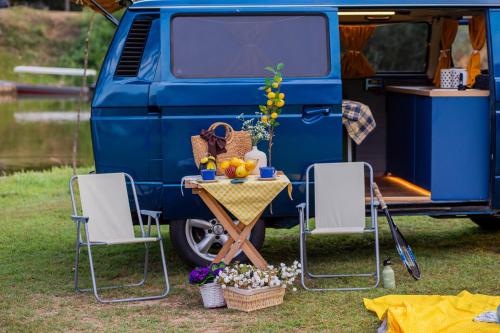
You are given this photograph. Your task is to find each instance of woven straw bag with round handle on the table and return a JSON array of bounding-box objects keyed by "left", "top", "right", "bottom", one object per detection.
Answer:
[{"left": 191, "top": 122, "right": 252, "bottom": 175}]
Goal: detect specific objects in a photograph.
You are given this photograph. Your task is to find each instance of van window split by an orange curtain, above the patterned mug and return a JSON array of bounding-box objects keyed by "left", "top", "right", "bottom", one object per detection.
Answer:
[{"left": 451, "top": 24, "right": 488, "bottom": 69}]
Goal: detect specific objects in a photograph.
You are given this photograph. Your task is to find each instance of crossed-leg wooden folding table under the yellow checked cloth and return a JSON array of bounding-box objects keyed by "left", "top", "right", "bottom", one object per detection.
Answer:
[{"left": 185, "top": 174, "right": 291, "bottom": 269}]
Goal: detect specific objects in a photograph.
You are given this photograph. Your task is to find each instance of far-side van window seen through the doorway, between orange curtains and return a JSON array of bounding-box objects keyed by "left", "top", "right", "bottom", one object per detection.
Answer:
[{"left": 364, "top": 22, "right": 430, "bottom": 73}]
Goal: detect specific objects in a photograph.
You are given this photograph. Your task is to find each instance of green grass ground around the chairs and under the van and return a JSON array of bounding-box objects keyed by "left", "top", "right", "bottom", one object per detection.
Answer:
[{"left": 0, "top": 169, "right": 500, "bottom": 332}]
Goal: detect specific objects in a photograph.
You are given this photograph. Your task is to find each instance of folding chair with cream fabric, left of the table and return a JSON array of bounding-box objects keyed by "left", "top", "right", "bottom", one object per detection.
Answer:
[{"left": 69, "top": 173, "right": 170, "bottom": 303}]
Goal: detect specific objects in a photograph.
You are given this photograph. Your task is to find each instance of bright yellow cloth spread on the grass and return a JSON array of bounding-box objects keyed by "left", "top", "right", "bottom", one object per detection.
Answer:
[{"left": 363, "top": 290, "right": 500, "bottom": 333}]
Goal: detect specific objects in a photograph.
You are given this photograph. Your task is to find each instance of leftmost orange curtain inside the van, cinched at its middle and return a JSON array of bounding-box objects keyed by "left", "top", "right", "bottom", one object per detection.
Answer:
[{"left": 340, "top": 25, "right": 375, "bottom": 79}]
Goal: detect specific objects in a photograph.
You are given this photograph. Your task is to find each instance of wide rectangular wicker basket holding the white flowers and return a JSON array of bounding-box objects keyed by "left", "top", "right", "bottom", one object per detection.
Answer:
[{"left": 222, "top": 286, "right": 285, "bottom": 312}]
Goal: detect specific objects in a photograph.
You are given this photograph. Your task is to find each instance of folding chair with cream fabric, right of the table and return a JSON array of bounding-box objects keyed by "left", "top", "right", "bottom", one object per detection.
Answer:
[{"left": 297, "top": 162, "right": 380, "bottom": 291}]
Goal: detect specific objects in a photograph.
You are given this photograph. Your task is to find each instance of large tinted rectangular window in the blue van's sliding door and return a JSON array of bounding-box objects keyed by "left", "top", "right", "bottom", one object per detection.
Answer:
[{"left": 170, "top": 15, "right": 330, "bottom": 78}]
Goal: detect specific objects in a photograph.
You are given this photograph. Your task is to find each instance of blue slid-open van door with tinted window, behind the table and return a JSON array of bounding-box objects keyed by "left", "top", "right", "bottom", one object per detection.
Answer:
[{"left": 150, "top": 5, "right": 343, "bottom": 217}]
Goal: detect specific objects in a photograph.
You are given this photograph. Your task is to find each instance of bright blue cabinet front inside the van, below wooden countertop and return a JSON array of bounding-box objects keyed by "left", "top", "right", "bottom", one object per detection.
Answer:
[{"left": 431, "top": 97, "right": 490, "bottom": 200}]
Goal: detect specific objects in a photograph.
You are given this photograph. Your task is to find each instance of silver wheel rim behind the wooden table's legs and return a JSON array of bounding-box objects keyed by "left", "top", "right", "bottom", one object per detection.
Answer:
[{"left": 186, "top": 219, "right": 245, "bottom": 261}]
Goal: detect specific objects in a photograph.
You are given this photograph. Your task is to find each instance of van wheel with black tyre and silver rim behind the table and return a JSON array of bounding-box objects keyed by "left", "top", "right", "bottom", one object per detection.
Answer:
[{"left": 170, "top": 218, "right": 266, "bottom": 266}]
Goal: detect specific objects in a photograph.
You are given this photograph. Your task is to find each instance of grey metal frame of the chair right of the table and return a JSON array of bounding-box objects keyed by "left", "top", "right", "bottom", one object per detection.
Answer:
[{"left": 297, "top": 162, "right": 380, "bottom": 291}]
